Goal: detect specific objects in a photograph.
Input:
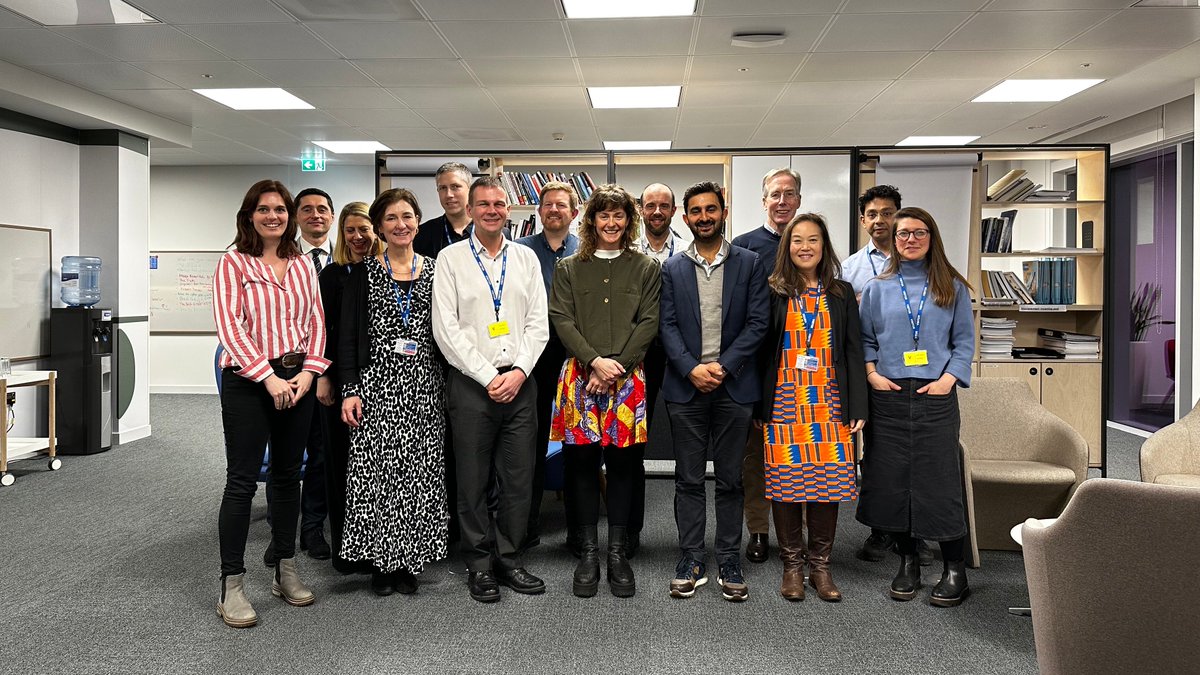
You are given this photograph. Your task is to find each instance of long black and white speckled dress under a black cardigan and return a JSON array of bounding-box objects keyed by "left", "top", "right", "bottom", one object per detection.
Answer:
[{"left": 342, "top": 258, "right": 449, "bottom": 573}]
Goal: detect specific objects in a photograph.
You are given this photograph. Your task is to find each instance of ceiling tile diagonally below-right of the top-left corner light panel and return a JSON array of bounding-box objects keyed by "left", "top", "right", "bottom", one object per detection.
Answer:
[{"left": 180, "top": 24, "right": 340, "bottom": 60}]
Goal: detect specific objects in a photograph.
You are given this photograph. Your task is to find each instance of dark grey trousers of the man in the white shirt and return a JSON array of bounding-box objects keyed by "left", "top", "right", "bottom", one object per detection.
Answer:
[{"left": 446, "top": 370, "right": 538, "bottom": 572}]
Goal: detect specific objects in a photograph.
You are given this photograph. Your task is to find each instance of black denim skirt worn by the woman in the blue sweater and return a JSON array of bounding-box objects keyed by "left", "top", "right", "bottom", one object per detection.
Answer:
[{"left": 856, "top": 380, "right": 967, "bottom": 542}]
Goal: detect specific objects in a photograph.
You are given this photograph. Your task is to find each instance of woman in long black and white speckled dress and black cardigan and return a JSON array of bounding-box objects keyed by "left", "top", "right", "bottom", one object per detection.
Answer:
[{"left": 337, "top": 189, "right": 449, "bottom": 596}]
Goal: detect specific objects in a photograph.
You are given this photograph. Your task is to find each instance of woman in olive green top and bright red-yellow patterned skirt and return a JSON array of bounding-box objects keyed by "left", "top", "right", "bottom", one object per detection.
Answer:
[{"left": 550, "top": 185, "right": 661, "bottom": 597}]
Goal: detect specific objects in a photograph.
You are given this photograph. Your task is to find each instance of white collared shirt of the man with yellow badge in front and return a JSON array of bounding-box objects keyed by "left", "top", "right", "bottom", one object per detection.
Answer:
[{"left": 433, "top": 232, "right": 550, "bottom": 387}]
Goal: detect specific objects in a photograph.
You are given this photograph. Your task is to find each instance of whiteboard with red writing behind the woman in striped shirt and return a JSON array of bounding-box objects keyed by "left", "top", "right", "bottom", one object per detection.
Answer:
[{"left": 150, "top": 251, "right": 224, "bottom": 333}]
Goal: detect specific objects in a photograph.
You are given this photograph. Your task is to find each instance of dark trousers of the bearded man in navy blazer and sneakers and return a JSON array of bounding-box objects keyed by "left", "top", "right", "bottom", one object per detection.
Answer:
[{"left": 667, "top": 386, "right": 751, "bottom": 563}]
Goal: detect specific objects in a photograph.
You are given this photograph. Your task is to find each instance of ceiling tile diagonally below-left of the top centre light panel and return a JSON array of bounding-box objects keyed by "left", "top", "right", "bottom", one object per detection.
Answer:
[{"left": 437, "top": 20, "right": 571, "bottom": 59}]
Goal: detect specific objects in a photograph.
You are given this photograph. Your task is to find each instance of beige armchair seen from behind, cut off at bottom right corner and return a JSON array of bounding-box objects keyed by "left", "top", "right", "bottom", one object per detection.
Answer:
[{"left": 1021, "top": 478, "right": 1200, "bottom": 675}]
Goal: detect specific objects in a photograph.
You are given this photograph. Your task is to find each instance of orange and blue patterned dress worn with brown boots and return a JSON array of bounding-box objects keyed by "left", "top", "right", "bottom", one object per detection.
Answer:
[{"left": 763, "top": 288, "right": 858, "bottom": 502}]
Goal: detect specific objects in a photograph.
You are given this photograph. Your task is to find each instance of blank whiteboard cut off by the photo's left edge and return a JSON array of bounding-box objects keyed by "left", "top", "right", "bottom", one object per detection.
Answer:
[{"left": 0, "top": 225, "right": 52, "bottom": 360}]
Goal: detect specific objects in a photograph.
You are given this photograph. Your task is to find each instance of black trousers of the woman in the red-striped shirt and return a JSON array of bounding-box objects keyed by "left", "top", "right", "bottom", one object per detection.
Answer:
[{"left": 217, "top": 366, "right": 316, "bottom": 577}]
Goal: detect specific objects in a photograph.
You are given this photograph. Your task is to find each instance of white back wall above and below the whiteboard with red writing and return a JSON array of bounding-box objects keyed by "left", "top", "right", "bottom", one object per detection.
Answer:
[{"left": 149, "top": 165, "right": 374, "bottom": 394}]
